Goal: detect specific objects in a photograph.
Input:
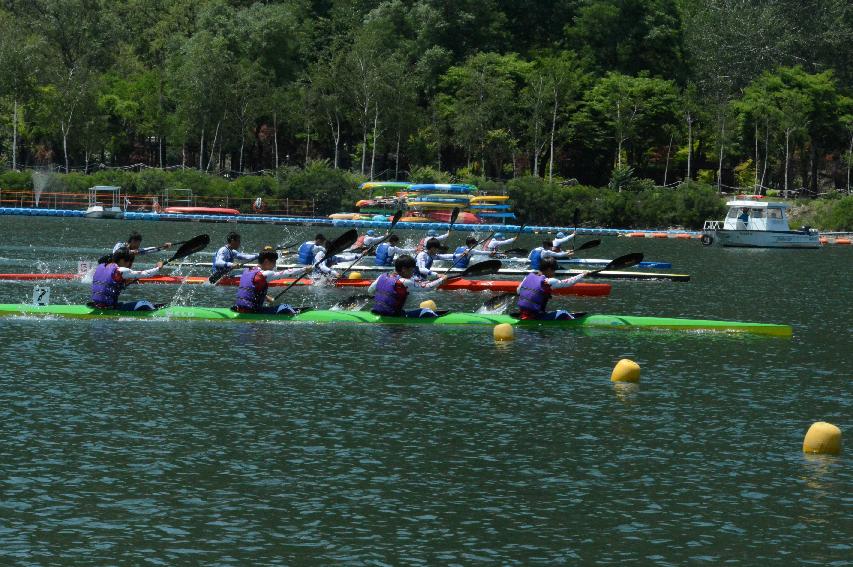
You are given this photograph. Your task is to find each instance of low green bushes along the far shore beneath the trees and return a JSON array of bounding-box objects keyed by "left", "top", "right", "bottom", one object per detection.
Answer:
[{"left": 0, "top": 166, "right": 853, "bottom": 231}]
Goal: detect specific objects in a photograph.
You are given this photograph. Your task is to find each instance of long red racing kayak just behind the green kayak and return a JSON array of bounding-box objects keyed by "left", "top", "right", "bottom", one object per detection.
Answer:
[{"left": 0, "top": 274, "right": 611, "bottom": 297}]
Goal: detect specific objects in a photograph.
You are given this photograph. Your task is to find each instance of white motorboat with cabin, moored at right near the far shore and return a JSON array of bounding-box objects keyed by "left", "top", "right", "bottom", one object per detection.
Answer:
[{"left": 702, "top": 199, "right": 820, "bottom": 248}]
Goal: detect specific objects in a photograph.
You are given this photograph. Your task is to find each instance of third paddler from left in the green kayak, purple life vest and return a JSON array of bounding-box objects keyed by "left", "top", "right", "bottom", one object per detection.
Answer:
[{"left": 367, "top": 254, "right": 447, "bottom": 318}]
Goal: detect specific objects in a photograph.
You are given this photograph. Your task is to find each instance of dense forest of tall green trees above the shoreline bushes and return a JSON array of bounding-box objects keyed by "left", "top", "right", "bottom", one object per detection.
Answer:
[{"left": 0, "top": 0, "right": 853, "bottom": 195}]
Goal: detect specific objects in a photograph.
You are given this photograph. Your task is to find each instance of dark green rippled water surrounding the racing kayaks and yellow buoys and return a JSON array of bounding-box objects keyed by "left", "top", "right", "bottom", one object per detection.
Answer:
[{"left": 0, "top": 217, "right": 853, "bottom": 565}]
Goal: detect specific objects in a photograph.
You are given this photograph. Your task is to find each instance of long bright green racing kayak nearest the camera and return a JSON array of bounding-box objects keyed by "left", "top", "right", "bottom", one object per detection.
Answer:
[{"left": 0, "top": 304, "right": 792, "bottom": 337}]
